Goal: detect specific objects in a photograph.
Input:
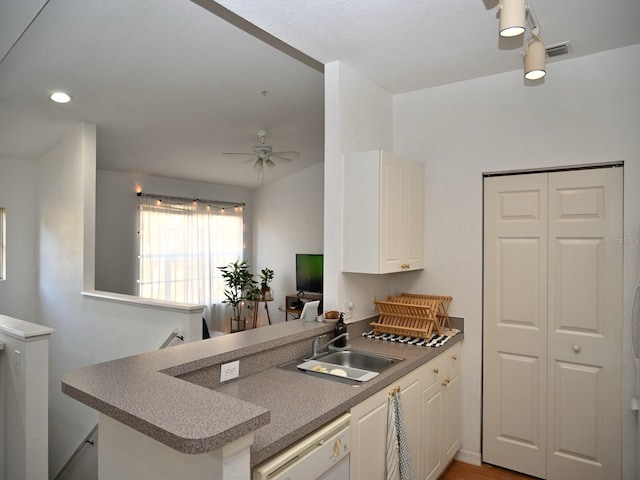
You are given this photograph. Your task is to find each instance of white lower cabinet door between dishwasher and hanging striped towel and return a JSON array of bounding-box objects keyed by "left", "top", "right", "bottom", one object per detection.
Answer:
[{"left": 350, "top": 391, "right": 388, "bottom": 480}]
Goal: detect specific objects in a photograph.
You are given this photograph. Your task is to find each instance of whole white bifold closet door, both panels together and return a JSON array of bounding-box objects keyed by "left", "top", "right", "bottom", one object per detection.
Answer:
[{"left": 483, "top": 168, "right": 622, "bottom": 480}]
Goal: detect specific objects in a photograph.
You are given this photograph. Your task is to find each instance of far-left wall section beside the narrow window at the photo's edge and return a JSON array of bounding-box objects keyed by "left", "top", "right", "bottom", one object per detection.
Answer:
[{"left": 0, "top": 158, "right": 37, "bottom": 321}]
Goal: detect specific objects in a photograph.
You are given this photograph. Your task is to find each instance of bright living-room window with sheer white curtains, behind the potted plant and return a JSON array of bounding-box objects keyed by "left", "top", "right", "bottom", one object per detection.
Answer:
[{"left": 138, "top": 194, "right": 244, "bottom": 306}]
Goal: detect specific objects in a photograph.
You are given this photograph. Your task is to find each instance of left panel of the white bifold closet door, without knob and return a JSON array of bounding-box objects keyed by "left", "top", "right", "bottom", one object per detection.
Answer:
[{"left": 482, "top": 173, "right": 548, "bottom": 478}]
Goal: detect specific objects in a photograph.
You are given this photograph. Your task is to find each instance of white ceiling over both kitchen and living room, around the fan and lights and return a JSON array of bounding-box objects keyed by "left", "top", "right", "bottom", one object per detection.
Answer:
[{"left": 0, "top": 0, "right": 640, "bottom": 188}]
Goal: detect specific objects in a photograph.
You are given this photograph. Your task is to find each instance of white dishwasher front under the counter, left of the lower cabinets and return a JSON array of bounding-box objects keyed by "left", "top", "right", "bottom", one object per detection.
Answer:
[{"left": 253, "top": 413, "right": 351, "bottom": 480}]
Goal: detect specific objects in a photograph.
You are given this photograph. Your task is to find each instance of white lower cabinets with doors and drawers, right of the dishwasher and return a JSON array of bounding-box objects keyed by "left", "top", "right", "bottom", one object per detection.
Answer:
[{"left": 350, "top": 344, "right": 460, "bottom": 480}]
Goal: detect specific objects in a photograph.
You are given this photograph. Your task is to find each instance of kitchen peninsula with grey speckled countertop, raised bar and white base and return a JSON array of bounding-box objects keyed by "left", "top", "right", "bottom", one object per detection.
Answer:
[{"left": 62, "top": 318, "right": 463, "bottom": 480}]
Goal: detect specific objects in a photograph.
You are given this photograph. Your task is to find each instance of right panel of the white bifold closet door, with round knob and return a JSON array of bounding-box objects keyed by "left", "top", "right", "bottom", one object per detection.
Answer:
[{"left": 547, "top": 168, "right": 623, "bottom": 480}]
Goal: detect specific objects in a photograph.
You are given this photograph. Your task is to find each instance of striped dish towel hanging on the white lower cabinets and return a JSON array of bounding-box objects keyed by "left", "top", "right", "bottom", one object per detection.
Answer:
[{"left": 387, "top": 391, "right": 415, "bottom": 480}]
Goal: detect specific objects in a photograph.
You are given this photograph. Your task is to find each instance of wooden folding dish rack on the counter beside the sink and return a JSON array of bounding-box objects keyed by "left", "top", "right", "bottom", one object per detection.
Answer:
[{"left": 371, "top": 293, "right": 453, "bottom": 338}]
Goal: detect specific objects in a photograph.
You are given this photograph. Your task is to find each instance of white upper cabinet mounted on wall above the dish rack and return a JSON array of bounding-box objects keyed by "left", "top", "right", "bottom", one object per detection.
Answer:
[{"left": 342, "top": 150, "right": 424, "bottom": 273}]
